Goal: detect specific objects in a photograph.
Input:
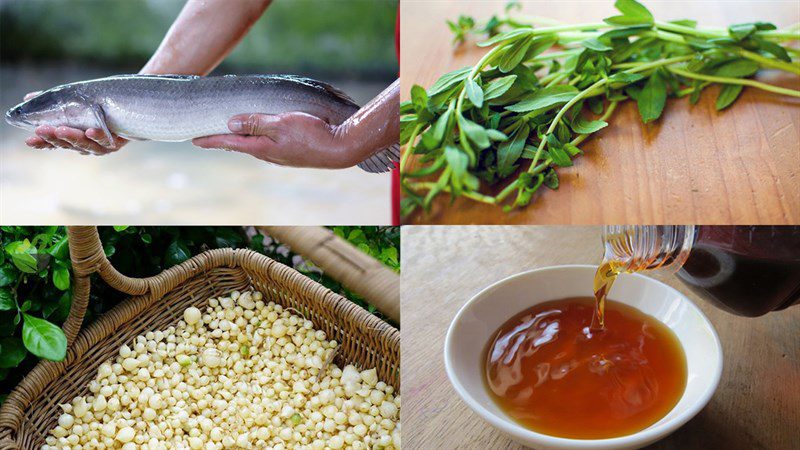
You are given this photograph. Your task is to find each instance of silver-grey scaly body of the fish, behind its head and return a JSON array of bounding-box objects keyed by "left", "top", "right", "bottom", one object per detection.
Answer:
[{"left": 75, "top": 76, "right": 358, "bottom": 141}]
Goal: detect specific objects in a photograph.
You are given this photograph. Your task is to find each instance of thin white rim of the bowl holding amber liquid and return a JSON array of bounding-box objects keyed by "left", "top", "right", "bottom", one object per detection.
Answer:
[{"left": 443, "top": 264, "right": 723, "bottom": 449}]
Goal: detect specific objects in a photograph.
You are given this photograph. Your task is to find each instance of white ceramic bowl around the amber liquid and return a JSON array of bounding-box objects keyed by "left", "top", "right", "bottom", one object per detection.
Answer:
[{"left": 444, "top": 266, "right": 722, "bottom": 449}]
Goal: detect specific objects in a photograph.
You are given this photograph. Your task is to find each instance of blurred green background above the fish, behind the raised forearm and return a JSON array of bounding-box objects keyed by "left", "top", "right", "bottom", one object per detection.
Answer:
[{"left": 0, "top": 0, "right": 398, "bottom": 79}]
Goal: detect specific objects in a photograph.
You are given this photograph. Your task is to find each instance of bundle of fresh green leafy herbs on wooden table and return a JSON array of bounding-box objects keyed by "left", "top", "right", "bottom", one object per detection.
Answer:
[{"left": 400, "top": 0, "right": 800, "bottom": 215}]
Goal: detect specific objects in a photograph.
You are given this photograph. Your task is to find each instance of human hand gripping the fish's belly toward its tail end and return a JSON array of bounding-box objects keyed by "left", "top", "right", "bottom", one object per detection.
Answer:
[{"left": 192, "top": 112, "right": 354, "bottom": 169}]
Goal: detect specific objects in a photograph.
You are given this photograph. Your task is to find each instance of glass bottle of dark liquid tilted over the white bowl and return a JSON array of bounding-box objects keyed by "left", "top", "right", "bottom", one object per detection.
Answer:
[{"left": 603, "top": 225, "right": 800, "bottom": 317}]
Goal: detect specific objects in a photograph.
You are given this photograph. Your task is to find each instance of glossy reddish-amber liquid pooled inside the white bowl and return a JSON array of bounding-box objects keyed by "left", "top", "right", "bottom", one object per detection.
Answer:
[{"left": 484, "top": 297, "right": 687, "bottom": 439}]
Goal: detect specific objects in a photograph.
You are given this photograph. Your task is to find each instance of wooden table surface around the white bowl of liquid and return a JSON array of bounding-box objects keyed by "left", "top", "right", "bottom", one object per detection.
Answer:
[{"left": 401, "top": 226, "right": 800, "bottom": 450}]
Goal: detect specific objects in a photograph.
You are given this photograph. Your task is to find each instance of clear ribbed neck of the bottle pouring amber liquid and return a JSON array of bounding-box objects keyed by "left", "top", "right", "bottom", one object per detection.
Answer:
[{"left": 603, "top": 225, "right": 695, "bottom": 273}]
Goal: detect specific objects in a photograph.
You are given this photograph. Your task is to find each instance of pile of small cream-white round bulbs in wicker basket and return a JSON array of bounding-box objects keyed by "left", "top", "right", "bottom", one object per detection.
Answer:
[{"left": 42, "top": 291, "right": 400, "bottom": 450}]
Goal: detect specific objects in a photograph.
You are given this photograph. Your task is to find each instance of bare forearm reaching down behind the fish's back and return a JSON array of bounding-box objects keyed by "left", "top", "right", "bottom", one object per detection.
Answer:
[{"left": 141, "top": 0, "right": 272, "bottom": 75}]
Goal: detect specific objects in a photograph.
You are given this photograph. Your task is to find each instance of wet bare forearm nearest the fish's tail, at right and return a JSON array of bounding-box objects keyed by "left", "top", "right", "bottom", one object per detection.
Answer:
[{"left": 336, "top": 79, "right": 400, "bottom": 162}]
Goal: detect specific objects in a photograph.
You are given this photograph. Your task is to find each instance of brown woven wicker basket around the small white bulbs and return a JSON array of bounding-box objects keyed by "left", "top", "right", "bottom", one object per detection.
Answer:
[{"left": 0, "top": 227, "right": 400, "bottom": 450}]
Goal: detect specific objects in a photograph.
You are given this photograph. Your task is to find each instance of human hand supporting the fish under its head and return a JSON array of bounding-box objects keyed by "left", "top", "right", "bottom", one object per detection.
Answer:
[{"left": 25, "top": 92, "right": 128, "bottom": 155}]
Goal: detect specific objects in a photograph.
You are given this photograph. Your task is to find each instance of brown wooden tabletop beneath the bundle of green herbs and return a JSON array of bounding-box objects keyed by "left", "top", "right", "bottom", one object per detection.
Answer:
[{"left": 401, "top": 0, "right": 800, "bottom": 224}]
